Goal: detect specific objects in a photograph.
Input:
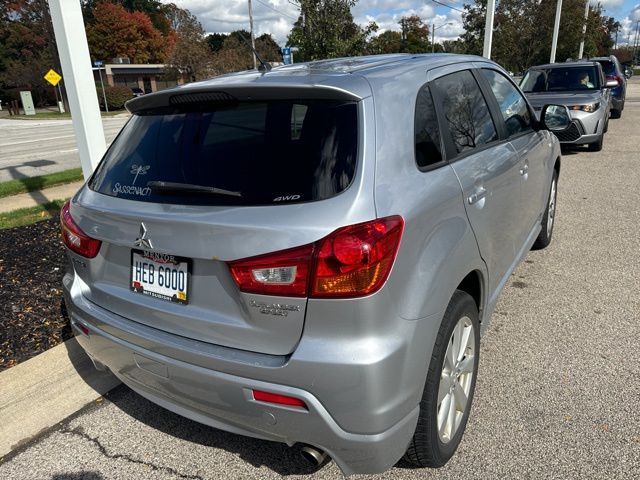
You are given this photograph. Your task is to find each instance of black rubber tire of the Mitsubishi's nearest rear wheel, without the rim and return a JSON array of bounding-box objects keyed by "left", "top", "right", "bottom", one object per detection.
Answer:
[{"left": 405, "top": 290, "right": 480, "bottom": 468}]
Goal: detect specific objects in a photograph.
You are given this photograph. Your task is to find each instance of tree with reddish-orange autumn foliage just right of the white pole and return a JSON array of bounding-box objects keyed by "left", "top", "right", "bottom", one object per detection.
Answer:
[{"left": 86, "top": 1, "right": 176, "bottom": 63}]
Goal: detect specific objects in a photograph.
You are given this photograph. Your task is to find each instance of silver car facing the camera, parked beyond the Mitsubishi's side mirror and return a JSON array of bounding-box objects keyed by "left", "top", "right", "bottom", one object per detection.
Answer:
[{"left": 520, "top": 61, "right": 617, "bottom": 152}]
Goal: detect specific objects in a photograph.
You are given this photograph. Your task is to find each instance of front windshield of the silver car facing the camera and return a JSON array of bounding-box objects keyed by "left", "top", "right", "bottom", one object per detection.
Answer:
[{"left": 520, "top": 66, "right": 600, "bottom": 93}]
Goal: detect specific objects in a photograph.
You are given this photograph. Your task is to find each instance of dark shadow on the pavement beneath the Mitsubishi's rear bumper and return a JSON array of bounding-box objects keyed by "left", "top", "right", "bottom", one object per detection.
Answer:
[{"left": 105, "top": 385, "right": 324, "bottom": 475}]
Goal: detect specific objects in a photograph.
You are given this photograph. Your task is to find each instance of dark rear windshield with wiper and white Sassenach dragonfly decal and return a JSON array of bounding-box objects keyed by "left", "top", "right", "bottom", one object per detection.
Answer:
[{"left": 89, "top": 100, "right": 358, "bottom": 205}]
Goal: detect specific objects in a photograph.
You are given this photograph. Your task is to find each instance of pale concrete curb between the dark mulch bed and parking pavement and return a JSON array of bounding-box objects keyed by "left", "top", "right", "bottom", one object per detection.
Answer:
[{"left": 0, "top": 339, "right": 120, "bottom": 458}]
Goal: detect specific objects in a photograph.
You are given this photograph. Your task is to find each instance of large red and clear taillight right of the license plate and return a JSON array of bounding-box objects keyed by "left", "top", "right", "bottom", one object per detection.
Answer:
[{"left": 229, "top": 216, "right": 404, "bottom": 298}]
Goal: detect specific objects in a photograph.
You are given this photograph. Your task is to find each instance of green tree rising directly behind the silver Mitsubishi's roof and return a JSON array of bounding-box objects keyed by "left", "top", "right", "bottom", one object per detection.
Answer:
[{"left": 287, "top": 0, "right": 378, "bottom": 61}]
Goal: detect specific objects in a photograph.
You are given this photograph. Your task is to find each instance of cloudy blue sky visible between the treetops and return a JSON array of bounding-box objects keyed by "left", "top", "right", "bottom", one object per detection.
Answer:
[{"left": 162, "top": 0, "right": 640, "bottom": 46}]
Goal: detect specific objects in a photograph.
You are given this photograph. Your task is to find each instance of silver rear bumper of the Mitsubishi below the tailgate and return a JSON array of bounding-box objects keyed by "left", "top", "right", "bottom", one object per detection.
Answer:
[{"left": 64, "top": 275, "right": 419, "bottom": 475}]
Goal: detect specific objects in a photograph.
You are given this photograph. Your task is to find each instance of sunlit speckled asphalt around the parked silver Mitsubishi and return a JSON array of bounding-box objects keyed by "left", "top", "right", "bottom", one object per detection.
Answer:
[{"left": 0, "top": 78, "right": 640, "bottom": 480}]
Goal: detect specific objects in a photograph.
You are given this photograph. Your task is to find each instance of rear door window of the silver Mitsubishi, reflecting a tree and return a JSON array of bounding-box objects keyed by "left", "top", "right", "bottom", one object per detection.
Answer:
[{"left": 433, "top": 70, "right": 498, "bottom": 153}]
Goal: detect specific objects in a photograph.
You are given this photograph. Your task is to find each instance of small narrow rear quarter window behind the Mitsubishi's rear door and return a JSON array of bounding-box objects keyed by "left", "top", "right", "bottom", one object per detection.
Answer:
[{"left": 414, "top": 85, "right": 442, "bottom": 168}]
